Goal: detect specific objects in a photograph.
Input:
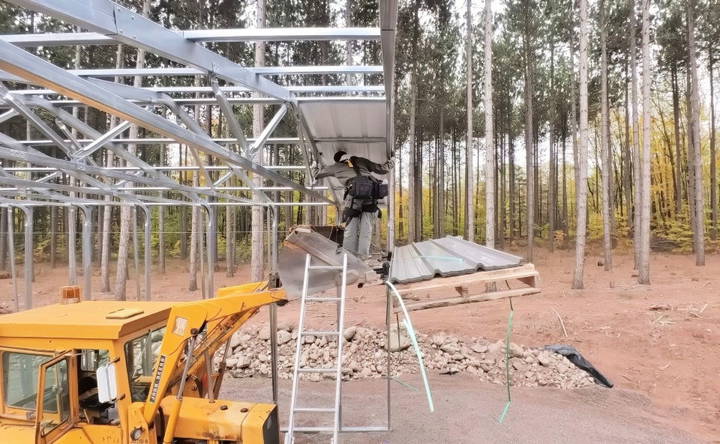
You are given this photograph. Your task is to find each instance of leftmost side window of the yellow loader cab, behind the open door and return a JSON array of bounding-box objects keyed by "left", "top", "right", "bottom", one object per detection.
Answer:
[{"left": 3, "top": 352, "right": 50, "bottom": 410}]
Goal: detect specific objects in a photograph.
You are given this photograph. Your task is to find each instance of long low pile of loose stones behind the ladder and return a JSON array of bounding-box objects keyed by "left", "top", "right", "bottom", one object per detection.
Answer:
[{"left": 221, "top": 326, "right": 594, "bottom": 389}]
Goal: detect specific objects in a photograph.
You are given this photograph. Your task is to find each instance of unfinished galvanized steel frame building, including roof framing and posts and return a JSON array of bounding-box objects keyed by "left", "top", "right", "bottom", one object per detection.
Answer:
[{"left": 0, "top": 0, "right": 397, "bottom": 308}]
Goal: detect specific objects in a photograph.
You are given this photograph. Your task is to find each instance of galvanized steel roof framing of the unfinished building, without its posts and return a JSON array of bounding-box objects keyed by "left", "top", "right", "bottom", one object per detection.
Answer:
[{"left": 0, "top": 0, "right": 397, "bottom": 210}]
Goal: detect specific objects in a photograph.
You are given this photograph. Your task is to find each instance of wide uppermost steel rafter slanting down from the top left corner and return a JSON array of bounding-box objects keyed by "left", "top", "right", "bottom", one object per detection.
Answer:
[{"left": 2, "top": 0, "right": 295, "bottom": 102}]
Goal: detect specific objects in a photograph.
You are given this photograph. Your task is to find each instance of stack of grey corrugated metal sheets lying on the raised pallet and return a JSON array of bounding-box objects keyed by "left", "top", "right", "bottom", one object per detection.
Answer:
[{"left": 390, "top": 236, "right": 522, "bottom": 284}]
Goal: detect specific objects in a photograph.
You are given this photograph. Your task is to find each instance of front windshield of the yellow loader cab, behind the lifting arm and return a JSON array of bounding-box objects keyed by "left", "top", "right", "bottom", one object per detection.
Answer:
[{"left": 125, "top": 327, "right": 165, "bottom": 402}]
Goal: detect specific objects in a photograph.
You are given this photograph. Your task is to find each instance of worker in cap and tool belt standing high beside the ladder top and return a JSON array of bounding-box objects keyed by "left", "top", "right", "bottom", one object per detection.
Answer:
[{"left": 315, "top": 150, "right": 395, "bottom": 260}]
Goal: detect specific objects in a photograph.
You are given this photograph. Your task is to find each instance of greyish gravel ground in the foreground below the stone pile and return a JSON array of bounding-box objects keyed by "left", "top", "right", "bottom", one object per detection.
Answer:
[{"left": 220, "top": 376, "right": 700, "bottom": 444}]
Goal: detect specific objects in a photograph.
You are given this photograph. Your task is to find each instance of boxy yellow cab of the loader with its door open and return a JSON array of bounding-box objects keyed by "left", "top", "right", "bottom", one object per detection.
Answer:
[{"left": 0, "top": 301, "right": 172, "bottom": 442}]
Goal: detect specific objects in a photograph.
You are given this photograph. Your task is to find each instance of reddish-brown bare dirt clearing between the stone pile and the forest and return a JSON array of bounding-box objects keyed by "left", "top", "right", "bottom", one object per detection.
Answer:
[{"left": 0, "top": 250, "right": 720, "bottom": 442}]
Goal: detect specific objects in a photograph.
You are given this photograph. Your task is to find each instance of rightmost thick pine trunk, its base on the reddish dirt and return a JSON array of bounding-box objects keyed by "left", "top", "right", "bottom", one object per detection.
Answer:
[{"left": 687, "top": 0, "right": 705, "bottom": 265}]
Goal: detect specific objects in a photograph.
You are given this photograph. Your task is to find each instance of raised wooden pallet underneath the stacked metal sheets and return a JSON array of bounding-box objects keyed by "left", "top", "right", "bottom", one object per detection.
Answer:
[{"left": 394, "top": 264, "right": 541, "bottom": 313}]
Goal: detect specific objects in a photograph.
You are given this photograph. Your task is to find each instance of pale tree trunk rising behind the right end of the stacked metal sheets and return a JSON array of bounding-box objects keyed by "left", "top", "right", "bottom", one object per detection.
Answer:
[{"left": 484, "top": 0, "right": 495, "bottom": 248}]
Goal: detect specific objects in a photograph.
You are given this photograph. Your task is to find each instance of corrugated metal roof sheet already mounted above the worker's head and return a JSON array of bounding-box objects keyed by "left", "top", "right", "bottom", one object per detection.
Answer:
[{"left": 299, "top": 98, "right": 387, "bottom": 164}]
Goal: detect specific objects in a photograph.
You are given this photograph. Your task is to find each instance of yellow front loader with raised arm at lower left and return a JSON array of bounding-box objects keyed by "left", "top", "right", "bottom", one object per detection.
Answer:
[{"left": 0, "top": 282, "right": 285, "bottom": 444}]
